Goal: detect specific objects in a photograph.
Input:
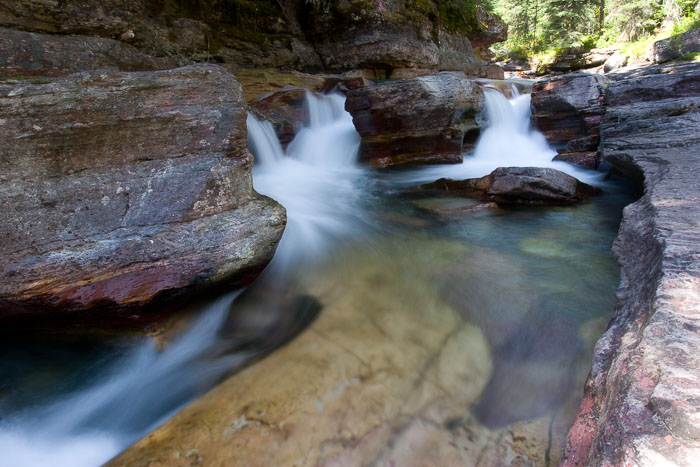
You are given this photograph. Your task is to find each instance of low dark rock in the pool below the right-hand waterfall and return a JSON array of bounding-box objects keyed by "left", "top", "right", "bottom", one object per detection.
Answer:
[{"left": 422, "top": 167, "right": 600, "bottom": 205}]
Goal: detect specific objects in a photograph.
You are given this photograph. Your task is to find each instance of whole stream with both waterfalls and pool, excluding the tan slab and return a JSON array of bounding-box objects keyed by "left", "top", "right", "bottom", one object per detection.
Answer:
[{"left": 0, "top": 87, "right": 635, "bottom": 466}]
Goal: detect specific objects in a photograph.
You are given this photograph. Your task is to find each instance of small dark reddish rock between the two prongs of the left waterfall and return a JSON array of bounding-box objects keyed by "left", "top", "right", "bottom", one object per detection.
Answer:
[{"left": 250, "top": 89, "right": 308, "bottom": 148}]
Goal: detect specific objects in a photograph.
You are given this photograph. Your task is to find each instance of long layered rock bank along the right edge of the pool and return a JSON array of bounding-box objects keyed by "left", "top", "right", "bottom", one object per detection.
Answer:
[{"left": 563, "top": 64, "right": 700, "bottom": 466}]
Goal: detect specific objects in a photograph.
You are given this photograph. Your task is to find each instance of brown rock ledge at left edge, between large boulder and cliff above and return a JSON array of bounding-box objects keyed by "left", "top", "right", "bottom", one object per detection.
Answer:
[{"left": 0, "top": 28, "right": 178, "bottom": 78}]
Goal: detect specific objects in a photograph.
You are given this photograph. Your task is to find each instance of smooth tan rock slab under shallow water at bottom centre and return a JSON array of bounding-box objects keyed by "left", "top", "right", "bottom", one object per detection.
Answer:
[{"left": 108, "top": 237, "right": 588, "bottom": 467}]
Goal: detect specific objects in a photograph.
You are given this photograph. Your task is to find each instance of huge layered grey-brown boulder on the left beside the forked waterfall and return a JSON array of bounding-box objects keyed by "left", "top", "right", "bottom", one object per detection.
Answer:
[{"left": 0, "top": 65, "right": 285, "bottom": 323}]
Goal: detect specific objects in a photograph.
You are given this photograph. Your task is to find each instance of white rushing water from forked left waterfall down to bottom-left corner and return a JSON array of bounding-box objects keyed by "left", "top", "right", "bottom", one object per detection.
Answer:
[{"left": 0, "top": 94, "right": 364, "bottom": 467}]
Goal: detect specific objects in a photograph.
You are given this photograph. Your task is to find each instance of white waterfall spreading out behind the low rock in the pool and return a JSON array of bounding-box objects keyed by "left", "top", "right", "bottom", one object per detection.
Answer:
[{"left": 401, "top": 87, "right": 603, "bottom": 185}]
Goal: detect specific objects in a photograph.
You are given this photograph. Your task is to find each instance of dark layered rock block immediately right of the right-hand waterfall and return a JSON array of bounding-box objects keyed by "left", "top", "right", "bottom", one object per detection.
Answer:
[{"left": 530, "top": 74, "right": 607, "bottom": 167}]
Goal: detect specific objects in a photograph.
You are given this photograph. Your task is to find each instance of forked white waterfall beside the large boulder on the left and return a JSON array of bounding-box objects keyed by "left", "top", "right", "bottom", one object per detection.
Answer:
[{"left": 248, "top": 93, "right": 368, "bottom": 269}]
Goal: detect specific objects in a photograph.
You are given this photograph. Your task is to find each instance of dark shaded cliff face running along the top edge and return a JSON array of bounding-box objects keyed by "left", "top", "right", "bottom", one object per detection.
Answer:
[{"left": 0, "top": 0, "right": 506, "bottom": 77}]
